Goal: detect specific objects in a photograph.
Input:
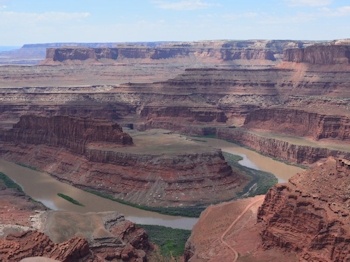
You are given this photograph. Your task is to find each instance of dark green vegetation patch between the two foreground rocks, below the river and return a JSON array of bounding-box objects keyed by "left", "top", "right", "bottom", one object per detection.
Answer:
[{"left": 138, "top": 225, "right": 191, "bottom": 258}]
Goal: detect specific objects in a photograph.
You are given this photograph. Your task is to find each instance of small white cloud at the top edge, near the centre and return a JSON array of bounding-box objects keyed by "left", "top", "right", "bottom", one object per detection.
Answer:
[{"left": 152, "top": 0, "right": 218, "bottom": 10}]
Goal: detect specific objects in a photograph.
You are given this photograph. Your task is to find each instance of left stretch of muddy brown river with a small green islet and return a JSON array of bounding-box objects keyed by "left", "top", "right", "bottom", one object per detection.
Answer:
[{"left": 0, "top": 159, "right": 198, "bottom": 229}]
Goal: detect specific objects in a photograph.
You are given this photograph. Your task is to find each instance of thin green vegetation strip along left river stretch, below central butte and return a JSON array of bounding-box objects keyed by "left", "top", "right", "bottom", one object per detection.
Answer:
[{"left": 85, "top": 190, "right": 206, "bottom": 217}]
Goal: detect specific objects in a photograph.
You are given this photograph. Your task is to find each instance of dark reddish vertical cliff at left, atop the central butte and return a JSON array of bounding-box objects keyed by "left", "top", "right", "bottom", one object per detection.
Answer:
[{"left": 0, "top": 115, "right": 132, "bottom": 154}]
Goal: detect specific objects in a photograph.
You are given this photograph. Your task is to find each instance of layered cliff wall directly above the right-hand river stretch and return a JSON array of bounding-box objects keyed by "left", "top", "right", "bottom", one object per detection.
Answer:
[{"left": 216, "top": 128, "right": 348, "bottom": 164}]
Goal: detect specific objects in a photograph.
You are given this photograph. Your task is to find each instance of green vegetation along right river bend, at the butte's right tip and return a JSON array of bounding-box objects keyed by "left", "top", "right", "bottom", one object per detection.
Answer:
[{"left": 222, "top": 152, "right": 278, "bottom": 197}]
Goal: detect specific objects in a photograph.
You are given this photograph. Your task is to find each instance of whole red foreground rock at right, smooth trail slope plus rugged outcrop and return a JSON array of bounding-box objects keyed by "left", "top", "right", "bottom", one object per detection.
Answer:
[{"left": 185, "top": 158, "right": 350, "bottom": 262}]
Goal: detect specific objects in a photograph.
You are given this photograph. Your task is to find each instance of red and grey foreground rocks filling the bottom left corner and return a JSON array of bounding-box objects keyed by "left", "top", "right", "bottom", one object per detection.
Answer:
[{"left": 0, "top": 176, "right": 153, "bottom": 262}]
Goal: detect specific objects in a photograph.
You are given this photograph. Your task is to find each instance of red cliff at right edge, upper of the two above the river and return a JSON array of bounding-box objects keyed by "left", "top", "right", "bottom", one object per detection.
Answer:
[{"left": 244, "top": 108, "right": 350, "bottom": 140}]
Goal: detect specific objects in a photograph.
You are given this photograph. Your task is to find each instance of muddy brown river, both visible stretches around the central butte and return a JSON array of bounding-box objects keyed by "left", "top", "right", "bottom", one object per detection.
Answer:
[{"left": 0, "top": 138, "right": 303, "bottom": 229}]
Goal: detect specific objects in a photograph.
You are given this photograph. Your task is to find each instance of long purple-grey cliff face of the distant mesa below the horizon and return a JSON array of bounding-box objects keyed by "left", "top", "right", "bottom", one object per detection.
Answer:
[{"left": 42, "top": 45, "right": 276, "bottom": 64}]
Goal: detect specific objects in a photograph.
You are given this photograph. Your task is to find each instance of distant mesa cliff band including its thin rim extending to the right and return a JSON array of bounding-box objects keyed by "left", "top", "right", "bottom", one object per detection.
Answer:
[{"left": 41, "top": 40, "right": 318, "bottom": 65}]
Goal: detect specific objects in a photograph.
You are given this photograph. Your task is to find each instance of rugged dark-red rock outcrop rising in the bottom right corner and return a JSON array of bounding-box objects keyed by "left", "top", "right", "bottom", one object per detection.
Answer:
[{"left": 258, "top": 159, "right": 350, "bottom": 262}]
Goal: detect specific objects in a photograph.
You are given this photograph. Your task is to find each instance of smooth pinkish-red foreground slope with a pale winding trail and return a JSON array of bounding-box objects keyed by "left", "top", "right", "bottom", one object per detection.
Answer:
[{"left": 185, "top": 196, "right": 297, "bottom": 262}]
